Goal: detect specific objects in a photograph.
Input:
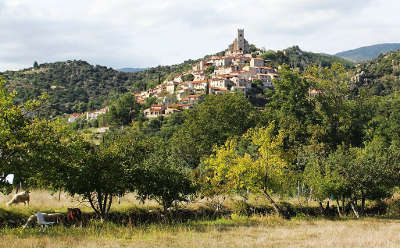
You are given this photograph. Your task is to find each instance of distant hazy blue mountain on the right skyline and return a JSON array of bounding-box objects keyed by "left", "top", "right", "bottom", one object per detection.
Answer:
[{"left": 335, "top": 43, "right": 400, "bottom": 62}]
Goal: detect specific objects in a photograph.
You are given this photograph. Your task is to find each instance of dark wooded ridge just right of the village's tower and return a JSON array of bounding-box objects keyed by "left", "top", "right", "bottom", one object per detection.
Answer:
[{"left": 261, "top": 46, "right": 354, "bottom": 70}]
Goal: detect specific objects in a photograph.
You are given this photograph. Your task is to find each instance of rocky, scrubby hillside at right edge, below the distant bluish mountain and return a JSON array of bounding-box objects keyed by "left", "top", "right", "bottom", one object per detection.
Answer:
[{"left": 353, "top": 50, "right": 400, "bottom": 95}]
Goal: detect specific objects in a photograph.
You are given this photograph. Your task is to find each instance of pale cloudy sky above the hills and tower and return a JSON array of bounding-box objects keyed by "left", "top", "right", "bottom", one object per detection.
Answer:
[{"left": 0, "top": 0, "right": 400, "bottom": 71}]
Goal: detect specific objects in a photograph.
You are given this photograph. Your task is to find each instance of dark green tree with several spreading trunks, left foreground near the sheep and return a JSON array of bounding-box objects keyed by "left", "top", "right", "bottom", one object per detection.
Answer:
[{"left": 38, "top": 132, "right": 150, "bottom": 220}]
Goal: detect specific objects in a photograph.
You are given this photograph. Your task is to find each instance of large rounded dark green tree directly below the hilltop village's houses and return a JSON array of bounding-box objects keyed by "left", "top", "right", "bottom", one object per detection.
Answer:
[{"left": 171, "top": 94, "right": 256, "bottom": 168}]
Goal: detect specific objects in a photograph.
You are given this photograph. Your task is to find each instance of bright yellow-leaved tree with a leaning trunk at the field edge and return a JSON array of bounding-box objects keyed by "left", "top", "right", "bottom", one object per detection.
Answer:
[{"left": 204, "top": 123, "right": 294, "bottom": 215}]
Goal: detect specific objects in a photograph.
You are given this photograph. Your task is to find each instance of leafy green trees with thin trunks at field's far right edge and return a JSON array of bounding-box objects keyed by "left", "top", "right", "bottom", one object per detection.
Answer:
[{"left": 304, "top": 137, "right": 400, "bottom": 217}]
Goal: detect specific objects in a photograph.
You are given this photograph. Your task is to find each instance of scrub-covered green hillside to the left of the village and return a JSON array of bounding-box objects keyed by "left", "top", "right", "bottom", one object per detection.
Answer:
[{"left": 0, "top": 60, "right": 195, "bottom": 115}]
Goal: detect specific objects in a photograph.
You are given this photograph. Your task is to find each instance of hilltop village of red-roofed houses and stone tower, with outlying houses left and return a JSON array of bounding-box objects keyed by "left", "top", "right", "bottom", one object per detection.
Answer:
[{"left": 69, "top": 29, "right": 279, "bottom": 122}]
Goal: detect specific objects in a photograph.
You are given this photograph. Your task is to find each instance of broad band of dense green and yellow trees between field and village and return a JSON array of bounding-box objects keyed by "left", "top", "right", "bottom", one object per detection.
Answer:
[{"left": 0, "top": 49, "right": 400, "bottom": 219}]
